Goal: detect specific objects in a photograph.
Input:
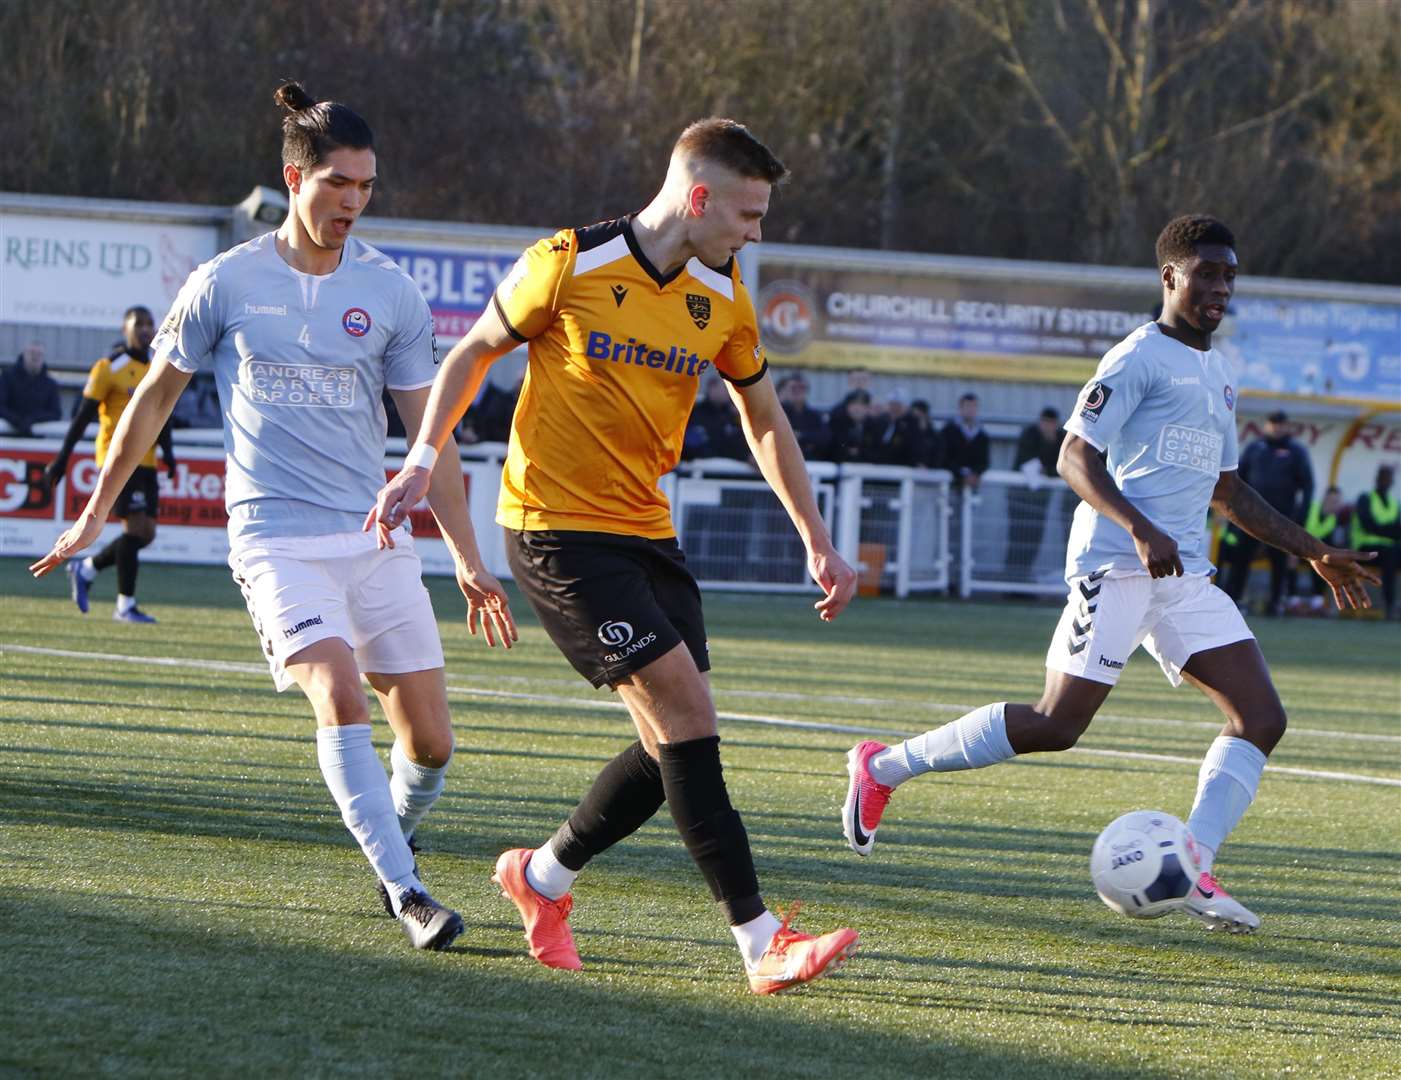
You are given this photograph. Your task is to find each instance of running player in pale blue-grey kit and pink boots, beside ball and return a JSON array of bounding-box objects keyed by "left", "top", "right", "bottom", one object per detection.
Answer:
[{"left": 842, "top": 216, "right": 1376, "bottom": 933}]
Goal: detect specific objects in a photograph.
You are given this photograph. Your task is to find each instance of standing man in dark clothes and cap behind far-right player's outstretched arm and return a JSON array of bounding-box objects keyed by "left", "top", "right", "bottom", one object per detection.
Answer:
[{"left": 1222, "top": 409, "right": 1313, "bottom": 615}]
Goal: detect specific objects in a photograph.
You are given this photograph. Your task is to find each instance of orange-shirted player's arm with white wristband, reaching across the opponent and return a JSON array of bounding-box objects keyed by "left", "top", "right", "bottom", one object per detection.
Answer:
[{"left": 364, "top": 304, "right": 520, "bottom": 537}]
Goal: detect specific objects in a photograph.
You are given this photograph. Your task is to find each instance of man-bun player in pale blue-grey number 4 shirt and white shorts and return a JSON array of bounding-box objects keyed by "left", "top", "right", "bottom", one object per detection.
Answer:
[{"left": 31, "top": 83, "right": 516, "bottom": 948}]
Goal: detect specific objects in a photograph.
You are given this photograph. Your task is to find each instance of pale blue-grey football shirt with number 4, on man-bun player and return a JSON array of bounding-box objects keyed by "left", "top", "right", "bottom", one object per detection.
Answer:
[{"left": 153, "top": 233, "right": 437, "bottom": 544}]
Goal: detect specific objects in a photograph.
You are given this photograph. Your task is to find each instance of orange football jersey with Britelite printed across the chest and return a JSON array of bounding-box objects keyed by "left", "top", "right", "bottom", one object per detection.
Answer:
[{"left": 493, "top": 217, "right": 768, "bottom": 539}]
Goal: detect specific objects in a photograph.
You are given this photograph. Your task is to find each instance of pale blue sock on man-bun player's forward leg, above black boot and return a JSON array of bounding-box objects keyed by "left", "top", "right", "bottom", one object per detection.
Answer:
[{"left": 317, "top": 724, "right": 423, "bottom": 913}]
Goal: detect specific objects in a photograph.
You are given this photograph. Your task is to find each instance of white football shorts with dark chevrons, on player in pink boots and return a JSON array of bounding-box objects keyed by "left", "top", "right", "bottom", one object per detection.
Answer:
[{"left": 1047, "top": 570, "right": 1255, "bottom": 686}]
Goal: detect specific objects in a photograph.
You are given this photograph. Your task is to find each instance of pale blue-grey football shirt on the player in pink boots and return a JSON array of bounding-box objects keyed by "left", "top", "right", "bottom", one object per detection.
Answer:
[{"left": 1065, "top": 322, "right": 1238, "bottom": 579}]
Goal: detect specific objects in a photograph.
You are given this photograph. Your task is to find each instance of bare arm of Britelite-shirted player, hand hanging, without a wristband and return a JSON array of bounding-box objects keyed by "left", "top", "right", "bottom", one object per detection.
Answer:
[{"left": 727, "top": 377, "right": 856, "bottom": 622}]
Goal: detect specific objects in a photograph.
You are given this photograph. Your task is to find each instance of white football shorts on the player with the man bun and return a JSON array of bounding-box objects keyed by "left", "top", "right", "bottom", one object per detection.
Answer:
[{"left": 228, "top": 529, "right": 443, "bottom": 692}]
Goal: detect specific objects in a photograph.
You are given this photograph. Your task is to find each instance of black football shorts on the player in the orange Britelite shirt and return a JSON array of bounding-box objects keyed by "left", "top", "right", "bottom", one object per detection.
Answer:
[{"left": 506, "top": 528, "right": 710, "bottom": 686}]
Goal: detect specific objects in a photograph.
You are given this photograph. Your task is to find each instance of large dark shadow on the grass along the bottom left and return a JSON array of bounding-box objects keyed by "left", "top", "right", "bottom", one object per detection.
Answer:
[{"left": 0, "top": 892, "right": 1193, "bottom": 1080}]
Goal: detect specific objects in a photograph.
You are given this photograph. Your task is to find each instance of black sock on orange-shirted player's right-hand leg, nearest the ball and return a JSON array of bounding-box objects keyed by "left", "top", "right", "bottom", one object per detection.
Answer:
[{"left": 658, "top": 735, "right": 765, "bottom": 926}]
